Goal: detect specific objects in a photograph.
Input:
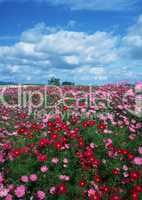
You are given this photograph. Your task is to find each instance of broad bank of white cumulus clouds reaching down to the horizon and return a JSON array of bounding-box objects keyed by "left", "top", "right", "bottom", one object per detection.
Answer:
[{"left": 0, "top": 16, "right": 142, "bottom": 83}]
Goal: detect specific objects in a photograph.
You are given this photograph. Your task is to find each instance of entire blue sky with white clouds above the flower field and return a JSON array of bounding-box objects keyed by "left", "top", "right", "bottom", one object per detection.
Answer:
[{"left": 0, "top": 0, "right": 142, "bottom": 84}]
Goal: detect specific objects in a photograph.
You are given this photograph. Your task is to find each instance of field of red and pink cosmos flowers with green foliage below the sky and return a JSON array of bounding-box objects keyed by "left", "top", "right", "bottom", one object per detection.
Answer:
[{"left": 0, "top": 83, "right": 142, "bottom": 200}]
